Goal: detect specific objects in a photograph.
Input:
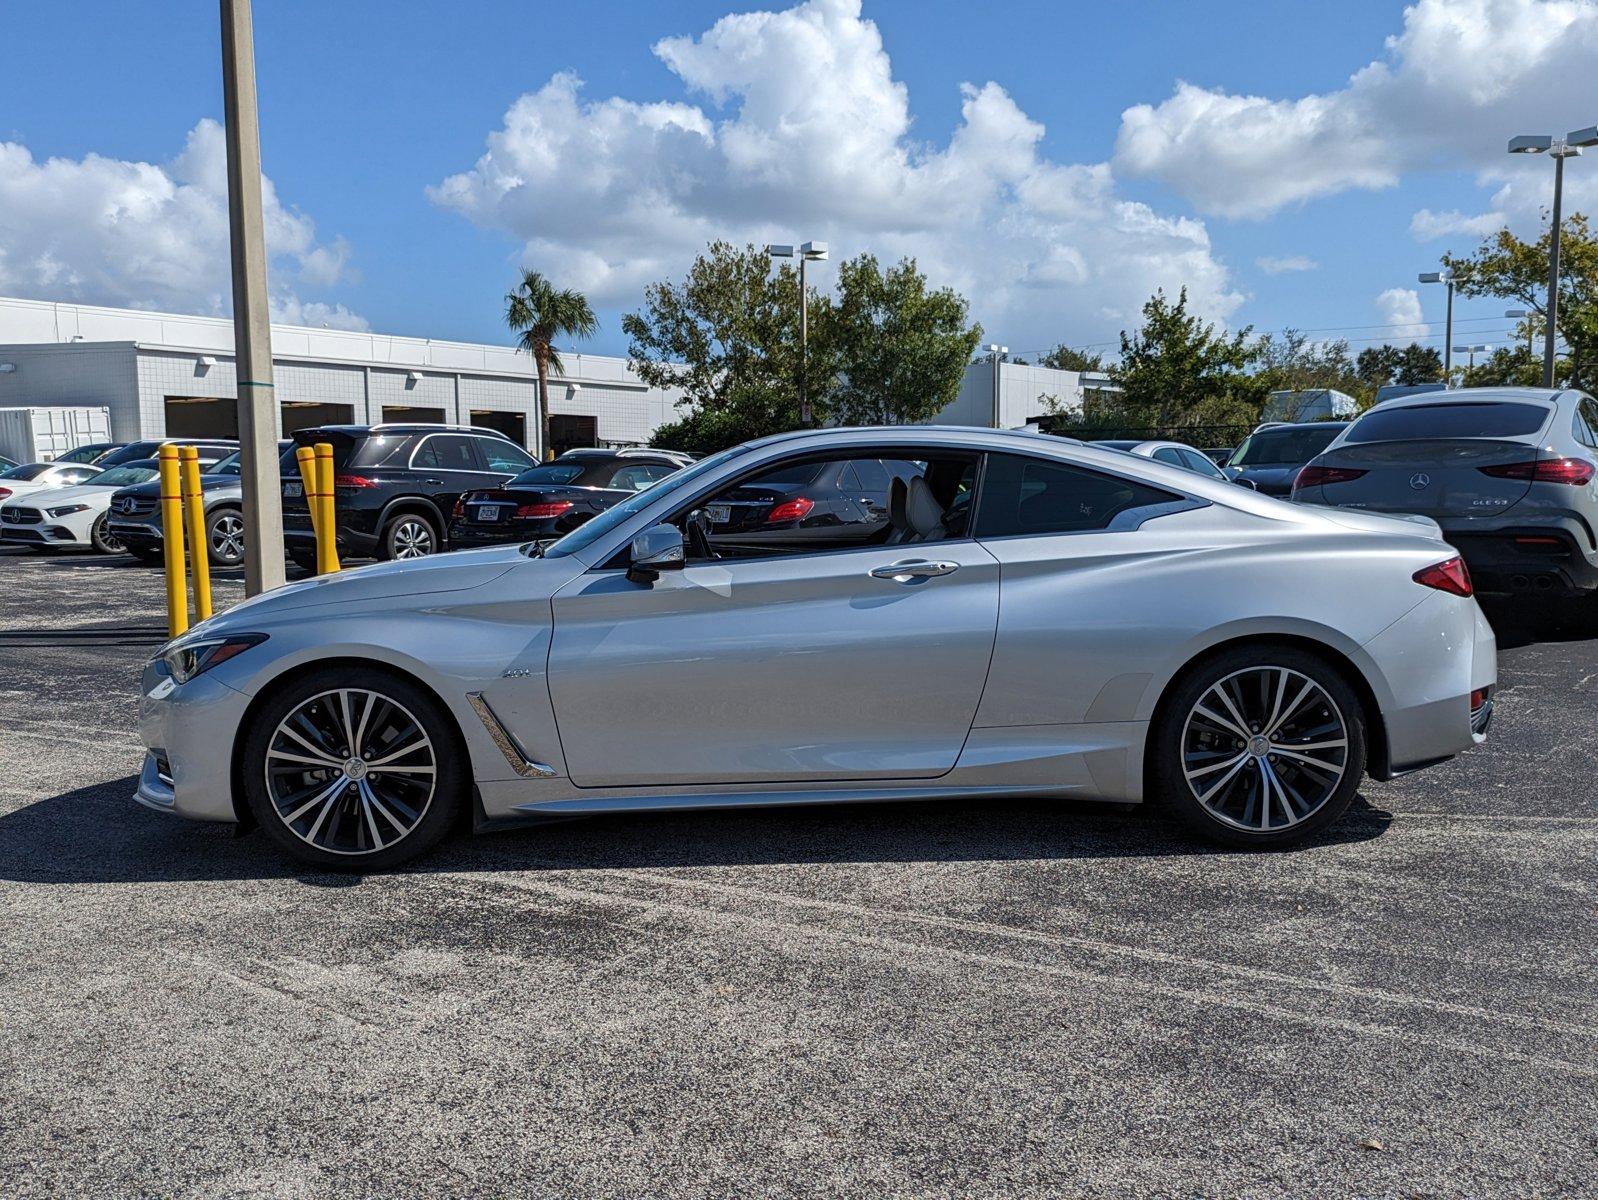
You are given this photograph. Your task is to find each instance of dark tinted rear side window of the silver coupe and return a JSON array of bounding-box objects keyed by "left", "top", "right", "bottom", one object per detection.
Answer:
[{"left": 976, "top": 454, "right": 1181, "bottom": 538}]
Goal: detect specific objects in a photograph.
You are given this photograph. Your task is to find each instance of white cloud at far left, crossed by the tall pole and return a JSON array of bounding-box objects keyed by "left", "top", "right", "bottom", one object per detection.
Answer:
[{"left": 0, "top": 120, "right": 366, "bottom": 329}]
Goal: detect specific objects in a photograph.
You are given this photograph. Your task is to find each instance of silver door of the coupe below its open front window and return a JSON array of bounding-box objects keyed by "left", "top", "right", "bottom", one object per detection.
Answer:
[{"left": 548, "top": 454, "right": 999, "bottom": 788}]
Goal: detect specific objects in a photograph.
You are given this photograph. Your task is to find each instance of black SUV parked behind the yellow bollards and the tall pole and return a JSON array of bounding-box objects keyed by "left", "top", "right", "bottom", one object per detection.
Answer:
[{"left": 283, "top": 423, "right": 537, "bottom": 569}]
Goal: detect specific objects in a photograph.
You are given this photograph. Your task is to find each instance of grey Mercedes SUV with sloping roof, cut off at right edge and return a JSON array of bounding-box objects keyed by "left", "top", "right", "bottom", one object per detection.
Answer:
[{"left": 1293, "top": 388, "right": 1598, "bottom": 594}]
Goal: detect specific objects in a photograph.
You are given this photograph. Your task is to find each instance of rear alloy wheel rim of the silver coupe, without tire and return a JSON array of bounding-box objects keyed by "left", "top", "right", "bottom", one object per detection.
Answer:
[{"left": 1183, "top": 665, "right": 1349, "bottom": 832}]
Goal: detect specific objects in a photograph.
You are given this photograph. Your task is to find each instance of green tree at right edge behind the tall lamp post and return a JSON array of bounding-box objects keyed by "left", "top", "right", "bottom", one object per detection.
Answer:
[{"left": 1443, "top": 213, "right": 1598, "bottom": 391}]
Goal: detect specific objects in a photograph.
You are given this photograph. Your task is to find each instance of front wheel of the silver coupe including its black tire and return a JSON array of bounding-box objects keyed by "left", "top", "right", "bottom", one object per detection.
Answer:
[{"left": 240, "top": 668, "right": 471, "bottom": 871}]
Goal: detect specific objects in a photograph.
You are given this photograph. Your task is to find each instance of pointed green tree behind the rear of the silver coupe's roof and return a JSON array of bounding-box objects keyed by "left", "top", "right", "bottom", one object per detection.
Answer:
[{"left": 1112, "top": 288, "right": 1264, "bottom": 430}]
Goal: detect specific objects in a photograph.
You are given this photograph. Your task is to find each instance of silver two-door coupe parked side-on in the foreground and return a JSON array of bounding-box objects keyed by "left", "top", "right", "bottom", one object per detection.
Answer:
[{"left": 136, "top": 427, "right": 1496, "bottom": 871}]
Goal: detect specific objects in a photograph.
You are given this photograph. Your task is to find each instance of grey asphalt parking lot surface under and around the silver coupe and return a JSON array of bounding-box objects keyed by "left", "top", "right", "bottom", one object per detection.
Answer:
[{"left": 0, "top": 554, "right": 1598, "bottom": 1197}]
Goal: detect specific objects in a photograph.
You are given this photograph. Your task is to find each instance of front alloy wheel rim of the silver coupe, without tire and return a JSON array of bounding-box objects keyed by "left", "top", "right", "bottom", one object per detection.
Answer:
[{"left": 265, "top": 687, "right": 438, "bottom": 855}]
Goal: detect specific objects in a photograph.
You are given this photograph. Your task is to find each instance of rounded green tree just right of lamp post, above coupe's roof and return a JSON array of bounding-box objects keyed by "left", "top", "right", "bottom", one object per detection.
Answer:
[{"left": 807, "top": 254, "right": 983, "bottom": 425}]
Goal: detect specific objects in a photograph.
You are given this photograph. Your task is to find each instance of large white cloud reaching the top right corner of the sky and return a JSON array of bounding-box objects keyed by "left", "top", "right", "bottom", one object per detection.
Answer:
[{"left": 1114, "top": 0, "right": 1598, "bottom": 221}]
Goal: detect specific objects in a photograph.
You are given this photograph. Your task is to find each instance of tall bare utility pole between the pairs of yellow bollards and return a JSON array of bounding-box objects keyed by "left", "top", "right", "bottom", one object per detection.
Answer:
[{"left": 218, "top": 0, "right": 286, "bottom": 596}]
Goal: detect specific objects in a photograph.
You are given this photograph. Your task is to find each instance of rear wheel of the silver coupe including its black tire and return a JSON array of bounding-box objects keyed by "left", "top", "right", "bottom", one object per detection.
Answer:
[{"left": 1151, "top": 642, "right": 1368, "bottom": 848}]
